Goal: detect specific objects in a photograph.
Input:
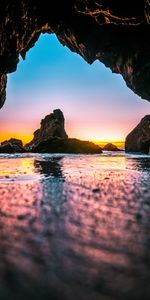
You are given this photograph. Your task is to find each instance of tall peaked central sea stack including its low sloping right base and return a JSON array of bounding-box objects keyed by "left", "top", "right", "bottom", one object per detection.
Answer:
[{"left": 25, "top": 109, "right": 102, "bottom": 154}]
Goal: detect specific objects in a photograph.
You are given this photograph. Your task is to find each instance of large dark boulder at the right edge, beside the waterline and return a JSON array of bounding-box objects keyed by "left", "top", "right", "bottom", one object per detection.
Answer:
[{"left": 125, "top": 115, "right": 150, "bottom": 153}]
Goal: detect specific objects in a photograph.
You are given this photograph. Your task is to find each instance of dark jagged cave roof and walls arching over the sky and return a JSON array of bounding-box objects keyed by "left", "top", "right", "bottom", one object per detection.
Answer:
[{"left": 0, "top": 0, "right": 150, "bottom": 106}]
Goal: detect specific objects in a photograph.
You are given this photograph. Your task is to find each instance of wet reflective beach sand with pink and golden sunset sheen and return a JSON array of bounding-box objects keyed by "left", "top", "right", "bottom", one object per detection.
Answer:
[{"left": 0, "top": 152, "right": 150, "bottom": 300}]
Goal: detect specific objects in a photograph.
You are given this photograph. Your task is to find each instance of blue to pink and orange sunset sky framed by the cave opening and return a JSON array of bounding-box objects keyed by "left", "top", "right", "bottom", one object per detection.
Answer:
[{"left": 0, "top": 34, "right": 150, "bottom": 142}]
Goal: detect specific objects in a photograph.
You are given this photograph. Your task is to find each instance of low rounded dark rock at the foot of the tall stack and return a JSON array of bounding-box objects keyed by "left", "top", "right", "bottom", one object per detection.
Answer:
[{"left": 29, "top": 137, "right": 102, "bottom": 154}]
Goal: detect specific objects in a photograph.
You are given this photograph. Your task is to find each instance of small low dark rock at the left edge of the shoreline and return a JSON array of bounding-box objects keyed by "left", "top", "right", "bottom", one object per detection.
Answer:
[{"left": 0, "top": 138, "right": 25, "bottom": 153}]
